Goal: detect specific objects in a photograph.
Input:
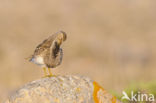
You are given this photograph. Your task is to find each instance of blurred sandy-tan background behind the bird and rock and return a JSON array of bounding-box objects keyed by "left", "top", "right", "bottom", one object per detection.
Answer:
[{"left": 0, "top": 0, "right": 156, "bottom": 102}]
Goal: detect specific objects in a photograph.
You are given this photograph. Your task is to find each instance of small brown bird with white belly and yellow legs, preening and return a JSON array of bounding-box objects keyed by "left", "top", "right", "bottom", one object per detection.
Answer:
[{"left": 29, "top": 31, "right": 67, "bottom": 77}]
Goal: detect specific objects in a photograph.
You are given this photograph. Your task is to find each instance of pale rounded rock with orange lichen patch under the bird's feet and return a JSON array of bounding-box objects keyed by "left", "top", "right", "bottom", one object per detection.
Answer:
[{"left": 5, "top": 76, "right": 120, "bottom": 103}]
